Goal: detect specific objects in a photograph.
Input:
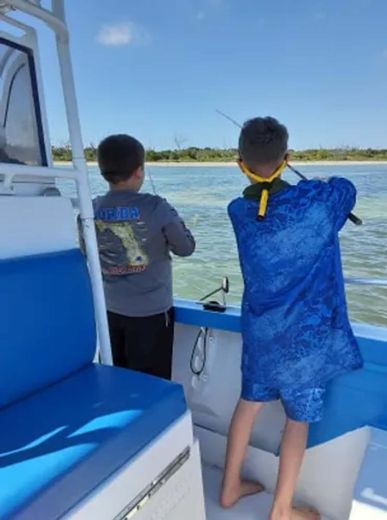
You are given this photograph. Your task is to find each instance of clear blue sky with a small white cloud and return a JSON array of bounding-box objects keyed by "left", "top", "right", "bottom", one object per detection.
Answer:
[{"left": 29, "top": 0, "right": 387, "bottom": 149}]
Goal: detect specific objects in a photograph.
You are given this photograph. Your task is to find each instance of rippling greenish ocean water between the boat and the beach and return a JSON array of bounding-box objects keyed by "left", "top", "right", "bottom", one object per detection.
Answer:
[{"left": 58, "top": 164, "right": 387, "bottom": 326}]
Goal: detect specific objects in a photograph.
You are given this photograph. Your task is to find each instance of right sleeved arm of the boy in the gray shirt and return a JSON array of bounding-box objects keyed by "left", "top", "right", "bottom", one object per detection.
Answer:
[{"left": 162, "top": 200, "right": 195, "bottom": 256}]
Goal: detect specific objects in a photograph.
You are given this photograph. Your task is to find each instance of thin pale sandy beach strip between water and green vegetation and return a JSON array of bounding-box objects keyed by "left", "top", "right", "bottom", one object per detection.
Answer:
[{"left": 54, "top": 161, "right": 387, "bottom": 168}]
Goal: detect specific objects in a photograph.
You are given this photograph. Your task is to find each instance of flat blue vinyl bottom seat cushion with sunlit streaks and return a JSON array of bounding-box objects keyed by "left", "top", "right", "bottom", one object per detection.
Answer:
[{"left": 0, "top": 365, "right": 186, "bottom": 520}]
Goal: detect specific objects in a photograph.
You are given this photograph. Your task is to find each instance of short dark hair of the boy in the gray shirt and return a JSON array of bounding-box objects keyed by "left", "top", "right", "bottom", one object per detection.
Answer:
[{"left": 97, "top": 134, "right": 145, "bottom": 184}]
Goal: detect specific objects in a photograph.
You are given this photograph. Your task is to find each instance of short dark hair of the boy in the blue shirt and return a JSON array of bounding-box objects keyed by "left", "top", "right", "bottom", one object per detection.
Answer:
[{"left": 239, "top": 117, "right": 289, "bottom": 166}]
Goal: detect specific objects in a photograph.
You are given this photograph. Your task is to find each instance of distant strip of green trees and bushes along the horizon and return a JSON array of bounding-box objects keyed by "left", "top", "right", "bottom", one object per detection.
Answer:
[{"left": 52, "top": 145, "right": 387, "bottom": 162}]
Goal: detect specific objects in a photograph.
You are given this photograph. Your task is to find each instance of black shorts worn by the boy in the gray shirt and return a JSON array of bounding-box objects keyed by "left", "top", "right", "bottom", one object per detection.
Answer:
[{"left": 108, "top": 309, "right": 174, "bottom": 379}]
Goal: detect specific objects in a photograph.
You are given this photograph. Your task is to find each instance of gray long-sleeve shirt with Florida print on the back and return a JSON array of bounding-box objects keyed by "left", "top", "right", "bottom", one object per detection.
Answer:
[{"left": 93, "top": 190, "right": 195, "bottom": 316}]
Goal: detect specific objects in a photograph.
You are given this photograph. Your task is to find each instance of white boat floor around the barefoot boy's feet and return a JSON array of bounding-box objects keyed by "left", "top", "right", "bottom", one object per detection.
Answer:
[{"left": 203, "top": 466, "right": 328, "bottom": 520}]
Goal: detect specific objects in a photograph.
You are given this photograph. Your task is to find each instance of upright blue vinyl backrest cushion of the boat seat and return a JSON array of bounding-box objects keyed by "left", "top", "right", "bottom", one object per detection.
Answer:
[{"left": 0, "top": 249, "right": 96, "bottom": 408}]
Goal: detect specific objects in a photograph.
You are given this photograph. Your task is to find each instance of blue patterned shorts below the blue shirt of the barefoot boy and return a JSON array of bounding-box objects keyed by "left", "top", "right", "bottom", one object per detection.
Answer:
[{"left": 241, "top": 381, "right": 325, "bottom": 423}]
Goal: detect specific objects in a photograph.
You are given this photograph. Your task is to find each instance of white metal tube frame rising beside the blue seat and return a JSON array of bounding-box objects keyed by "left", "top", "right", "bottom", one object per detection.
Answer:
[{"left": 0, "top": 0, "right": 112, "bottom": 364}]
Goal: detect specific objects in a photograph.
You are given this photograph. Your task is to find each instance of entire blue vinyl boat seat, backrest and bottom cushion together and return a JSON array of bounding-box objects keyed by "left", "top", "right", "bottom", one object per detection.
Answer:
[{"left": 0, "top": 249, "right": 186, "bottom": 520}]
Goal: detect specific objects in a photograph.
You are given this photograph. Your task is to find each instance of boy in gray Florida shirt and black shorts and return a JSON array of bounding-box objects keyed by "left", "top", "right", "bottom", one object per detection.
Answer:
[{"left": 93, "top": 135, "right": 195, "bottom": 379}]
